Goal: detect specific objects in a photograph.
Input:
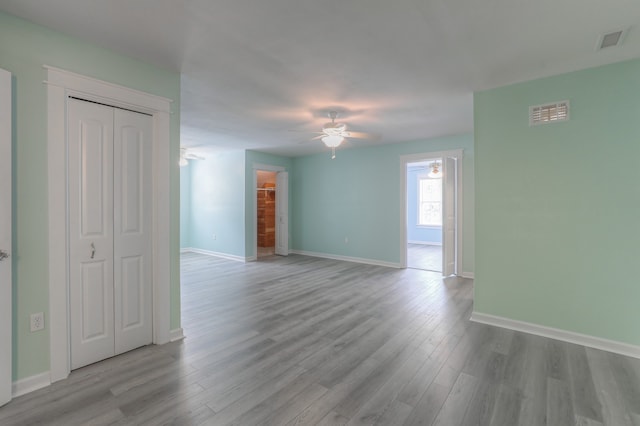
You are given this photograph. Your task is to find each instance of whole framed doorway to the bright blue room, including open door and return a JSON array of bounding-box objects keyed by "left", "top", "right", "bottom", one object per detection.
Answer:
[{"left": 400, "top": 150, "right": 462, "bottom": 276}]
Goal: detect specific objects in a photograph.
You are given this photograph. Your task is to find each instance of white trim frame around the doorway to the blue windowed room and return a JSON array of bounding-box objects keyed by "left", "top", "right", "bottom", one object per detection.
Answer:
[{"left": 400, "top": 149, "right": 464, "bottom": 275}]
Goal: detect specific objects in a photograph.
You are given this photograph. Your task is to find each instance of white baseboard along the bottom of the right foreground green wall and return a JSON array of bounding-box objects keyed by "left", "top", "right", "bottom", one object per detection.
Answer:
[{"left": 470, "top": 311, "right": 640, "bottom": 358}]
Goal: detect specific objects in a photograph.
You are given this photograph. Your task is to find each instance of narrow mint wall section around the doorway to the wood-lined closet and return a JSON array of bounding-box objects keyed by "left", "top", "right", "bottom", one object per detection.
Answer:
[{"left": 245, "top": 151, "right": 293, "bottom": 258}]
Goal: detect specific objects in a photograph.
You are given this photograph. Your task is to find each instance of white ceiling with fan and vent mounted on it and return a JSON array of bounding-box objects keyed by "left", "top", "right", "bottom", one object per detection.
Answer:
[{"left": 0, "top": 0, "right": 640, "bottom": 155}]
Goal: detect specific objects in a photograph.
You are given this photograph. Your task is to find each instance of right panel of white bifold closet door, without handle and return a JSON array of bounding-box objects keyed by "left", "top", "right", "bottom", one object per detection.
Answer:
[{"left": 114, "top": 110, "right": 153, "bottom": 353}]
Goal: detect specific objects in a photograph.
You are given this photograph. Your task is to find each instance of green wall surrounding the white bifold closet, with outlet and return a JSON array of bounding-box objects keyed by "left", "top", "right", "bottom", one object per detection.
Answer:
[{"left": 0, "top": 13, "right": 180, "bottom": 380}]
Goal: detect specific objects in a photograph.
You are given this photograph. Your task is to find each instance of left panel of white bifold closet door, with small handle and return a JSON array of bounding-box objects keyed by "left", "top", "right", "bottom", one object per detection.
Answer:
[{"left": 68, "top": 99, "right": 114, "bottom": 369}]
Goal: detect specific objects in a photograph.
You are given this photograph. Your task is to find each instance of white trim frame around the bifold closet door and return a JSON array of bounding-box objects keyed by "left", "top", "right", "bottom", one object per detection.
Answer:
[{"left": 44, "top": 66, "right": 172, "bottom": 382}]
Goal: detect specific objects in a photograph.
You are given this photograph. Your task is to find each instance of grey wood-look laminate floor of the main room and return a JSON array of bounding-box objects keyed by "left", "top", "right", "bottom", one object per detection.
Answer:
[{"left": 0, "top": 254, "right": 640, "bottom": 426}]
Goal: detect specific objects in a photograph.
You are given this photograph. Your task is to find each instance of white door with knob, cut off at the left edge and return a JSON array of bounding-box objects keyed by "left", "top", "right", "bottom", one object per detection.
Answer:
[{"left": 0, "top": 69, "right": 13, "bottom": 406}]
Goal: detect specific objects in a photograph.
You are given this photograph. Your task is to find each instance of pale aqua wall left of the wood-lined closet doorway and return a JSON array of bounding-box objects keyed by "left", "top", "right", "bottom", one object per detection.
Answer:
[{"left": 189, "top": 150, "right": 245, "bottom": 257}]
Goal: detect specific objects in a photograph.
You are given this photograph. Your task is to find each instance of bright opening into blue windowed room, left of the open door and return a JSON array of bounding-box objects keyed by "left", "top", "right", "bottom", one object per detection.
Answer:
[{"left": 407, "top": 158, "right": 443, "bottom": 272}]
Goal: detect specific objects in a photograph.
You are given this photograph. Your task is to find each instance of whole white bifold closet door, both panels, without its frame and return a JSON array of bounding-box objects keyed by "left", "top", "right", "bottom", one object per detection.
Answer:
[{"left": 68, "top": 99, "right": 153, "bottom": 369}]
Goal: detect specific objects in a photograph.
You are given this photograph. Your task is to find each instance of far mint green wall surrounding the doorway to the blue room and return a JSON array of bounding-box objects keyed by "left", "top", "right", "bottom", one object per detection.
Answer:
[{"left": 290, "top": 134, "right": 474, "bottom": 273}]
